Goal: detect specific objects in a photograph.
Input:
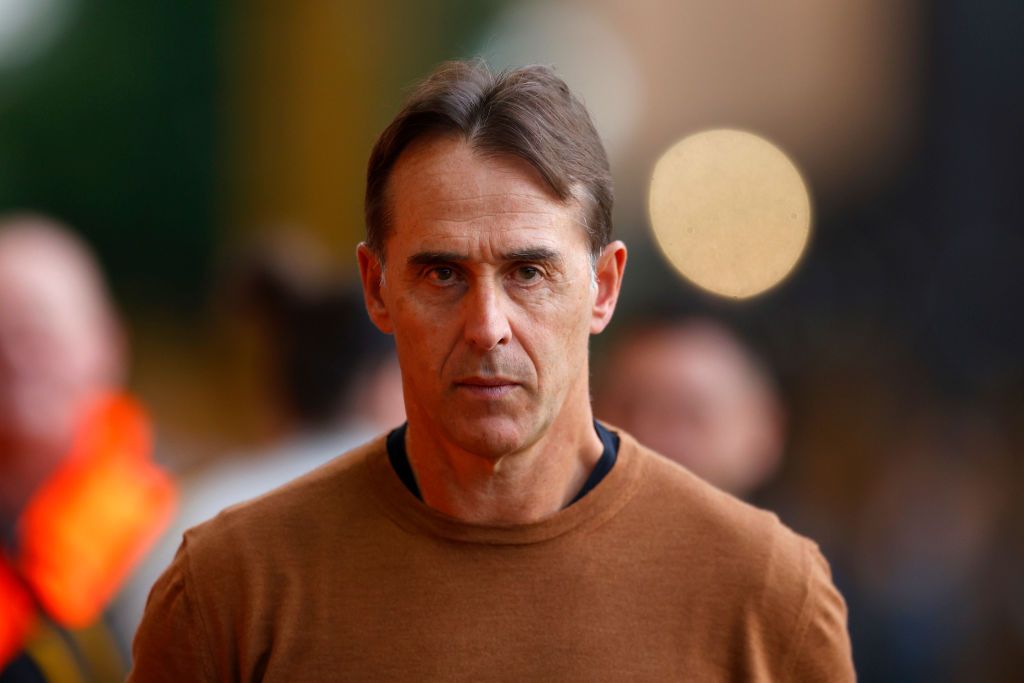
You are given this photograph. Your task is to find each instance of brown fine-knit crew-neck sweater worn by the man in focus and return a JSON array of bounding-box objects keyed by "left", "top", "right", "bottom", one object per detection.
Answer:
[{"left": 129, "top": 431, "right": 854, "bottom": 683}]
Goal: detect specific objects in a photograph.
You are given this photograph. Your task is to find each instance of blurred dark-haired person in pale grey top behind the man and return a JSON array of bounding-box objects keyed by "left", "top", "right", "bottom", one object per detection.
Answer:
[{"left": 116, "top": 233, "right": 406, "bottom": 637}]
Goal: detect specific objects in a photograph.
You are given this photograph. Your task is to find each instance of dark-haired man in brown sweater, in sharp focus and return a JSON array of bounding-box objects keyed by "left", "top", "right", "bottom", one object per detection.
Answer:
[{"left": 128, "top": 62, "right": 853, "bottom": 681}]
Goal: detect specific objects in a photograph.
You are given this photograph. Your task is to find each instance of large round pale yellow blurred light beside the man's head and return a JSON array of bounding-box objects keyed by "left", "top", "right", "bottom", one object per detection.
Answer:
[{"left": 648, "top": 129, "right": 811, "bottom": 299}]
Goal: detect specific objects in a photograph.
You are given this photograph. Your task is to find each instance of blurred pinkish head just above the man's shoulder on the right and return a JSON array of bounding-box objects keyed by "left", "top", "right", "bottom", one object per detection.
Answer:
[{"left": 595, "top": 317, "right": 785, "bottom": 497}]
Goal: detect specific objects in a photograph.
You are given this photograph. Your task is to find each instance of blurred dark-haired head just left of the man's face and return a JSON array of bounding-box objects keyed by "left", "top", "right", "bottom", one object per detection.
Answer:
[{"left": 231, "top": 233, "right": 406, "bottom": 433}]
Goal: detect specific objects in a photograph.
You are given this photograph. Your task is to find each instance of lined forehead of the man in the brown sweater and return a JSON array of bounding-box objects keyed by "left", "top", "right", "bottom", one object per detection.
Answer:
[{"left": 387, "top": 137, "right": 587, "bottom": 251}]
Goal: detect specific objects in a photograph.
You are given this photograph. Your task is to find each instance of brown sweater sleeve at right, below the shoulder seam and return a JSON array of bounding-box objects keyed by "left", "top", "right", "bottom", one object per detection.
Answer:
[{"left": 786, "top": 541, "right": 856, "bottom": 681}]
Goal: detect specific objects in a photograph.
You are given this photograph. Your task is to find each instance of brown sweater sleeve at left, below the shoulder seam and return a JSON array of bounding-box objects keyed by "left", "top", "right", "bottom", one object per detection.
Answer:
[{"left": 128, "top": 544, "right": 216, "bottom": 683}]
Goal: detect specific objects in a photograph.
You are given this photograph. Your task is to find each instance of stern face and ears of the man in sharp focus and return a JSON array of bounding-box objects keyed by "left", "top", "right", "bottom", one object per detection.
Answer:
[{"left": 359, "top": 137, "right": 625, "bottom": 458}]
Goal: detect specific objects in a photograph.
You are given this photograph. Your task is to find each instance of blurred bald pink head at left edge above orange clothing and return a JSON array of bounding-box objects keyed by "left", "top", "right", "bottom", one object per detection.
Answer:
[{"left": 0, "top": 228, "right": 120, "bottom": 469}]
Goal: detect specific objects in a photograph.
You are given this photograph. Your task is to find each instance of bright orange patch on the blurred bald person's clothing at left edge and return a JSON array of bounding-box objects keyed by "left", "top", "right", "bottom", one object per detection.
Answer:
[{"left": 17, "top": 394, "right": 176, "bottom": 629}]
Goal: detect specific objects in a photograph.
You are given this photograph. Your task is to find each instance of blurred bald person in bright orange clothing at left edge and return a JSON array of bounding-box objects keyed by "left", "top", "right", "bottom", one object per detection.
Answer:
[{"left": 0, "top": 215, "right": 174, "bottom": 683}]
